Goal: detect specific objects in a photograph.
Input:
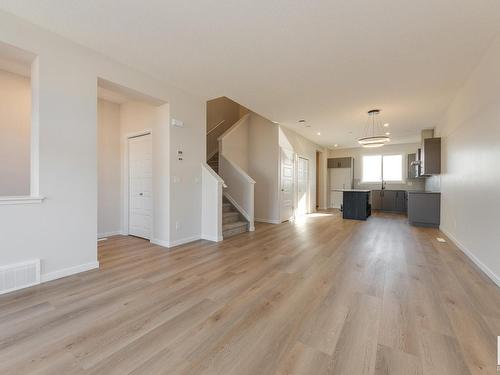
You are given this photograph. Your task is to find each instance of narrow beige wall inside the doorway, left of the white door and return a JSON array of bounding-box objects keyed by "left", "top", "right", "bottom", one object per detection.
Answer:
[{"left": 97, "top": 99, "right": 122, "bottom": 237}]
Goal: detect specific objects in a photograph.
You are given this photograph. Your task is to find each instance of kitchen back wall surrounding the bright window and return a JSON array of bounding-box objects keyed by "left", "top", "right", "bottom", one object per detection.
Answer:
[{"left": 328, "top": 143, "right": 425, "bottom": 190}]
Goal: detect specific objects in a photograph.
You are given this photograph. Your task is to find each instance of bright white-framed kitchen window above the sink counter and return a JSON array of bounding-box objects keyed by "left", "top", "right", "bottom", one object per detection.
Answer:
[{"left": 361, "top": 155, "right": 403, "bottom": 182}]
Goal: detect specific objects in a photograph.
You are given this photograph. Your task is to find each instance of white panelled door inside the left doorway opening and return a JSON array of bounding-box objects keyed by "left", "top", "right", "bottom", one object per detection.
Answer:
[{"left": 128, "top": 134, "right": 153, "bottom": 239}]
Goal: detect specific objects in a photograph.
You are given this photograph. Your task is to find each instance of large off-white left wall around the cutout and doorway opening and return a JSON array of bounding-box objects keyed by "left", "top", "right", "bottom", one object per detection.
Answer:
[{"left": 0, "top": 12, "right": 206, "bottom": 280}]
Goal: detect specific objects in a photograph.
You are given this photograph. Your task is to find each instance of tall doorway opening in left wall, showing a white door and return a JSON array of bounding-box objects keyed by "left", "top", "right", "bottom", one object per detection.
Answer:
[{"left": 97, "top": 79, "right": 169, "bottom": 244}]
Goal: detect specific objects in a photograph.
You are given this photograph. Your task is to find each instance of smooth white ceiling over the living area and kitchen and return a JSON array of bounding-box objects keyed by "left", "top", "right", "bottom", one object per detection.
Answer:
[{"left": 0, "top": 0, "right": 500, "bottom": 147}]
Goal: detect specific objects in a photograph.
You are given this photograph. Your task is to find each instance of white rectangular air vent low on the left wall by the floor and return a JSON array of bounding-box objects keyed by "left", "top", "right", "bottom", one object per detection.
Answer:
[{"left": 0, "top": 259, "right": 40, "bottom": 294}]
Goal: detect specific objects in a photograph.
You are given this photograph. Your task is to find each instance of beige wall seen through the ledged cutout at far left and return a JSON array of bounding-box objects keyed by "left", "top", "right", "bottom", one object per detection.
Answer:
[{"left": 0, "top": 70, "right": 31, "bottom": 196}]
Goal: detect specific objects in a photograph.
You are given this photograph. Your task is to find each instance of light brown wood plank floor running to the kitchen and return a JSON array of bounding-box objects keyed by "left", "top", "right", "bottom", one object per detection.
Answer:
[{"left": 0, "top": 213, "right": 500, "bottom": 375}]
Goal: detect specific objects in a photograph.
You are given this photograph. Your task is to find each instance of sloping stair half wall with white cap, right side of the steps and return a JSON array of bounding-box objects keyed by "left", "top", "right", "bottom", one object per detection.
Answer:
[{"left": 219, "top": 154, "right": 255, "bottom": 231}]
